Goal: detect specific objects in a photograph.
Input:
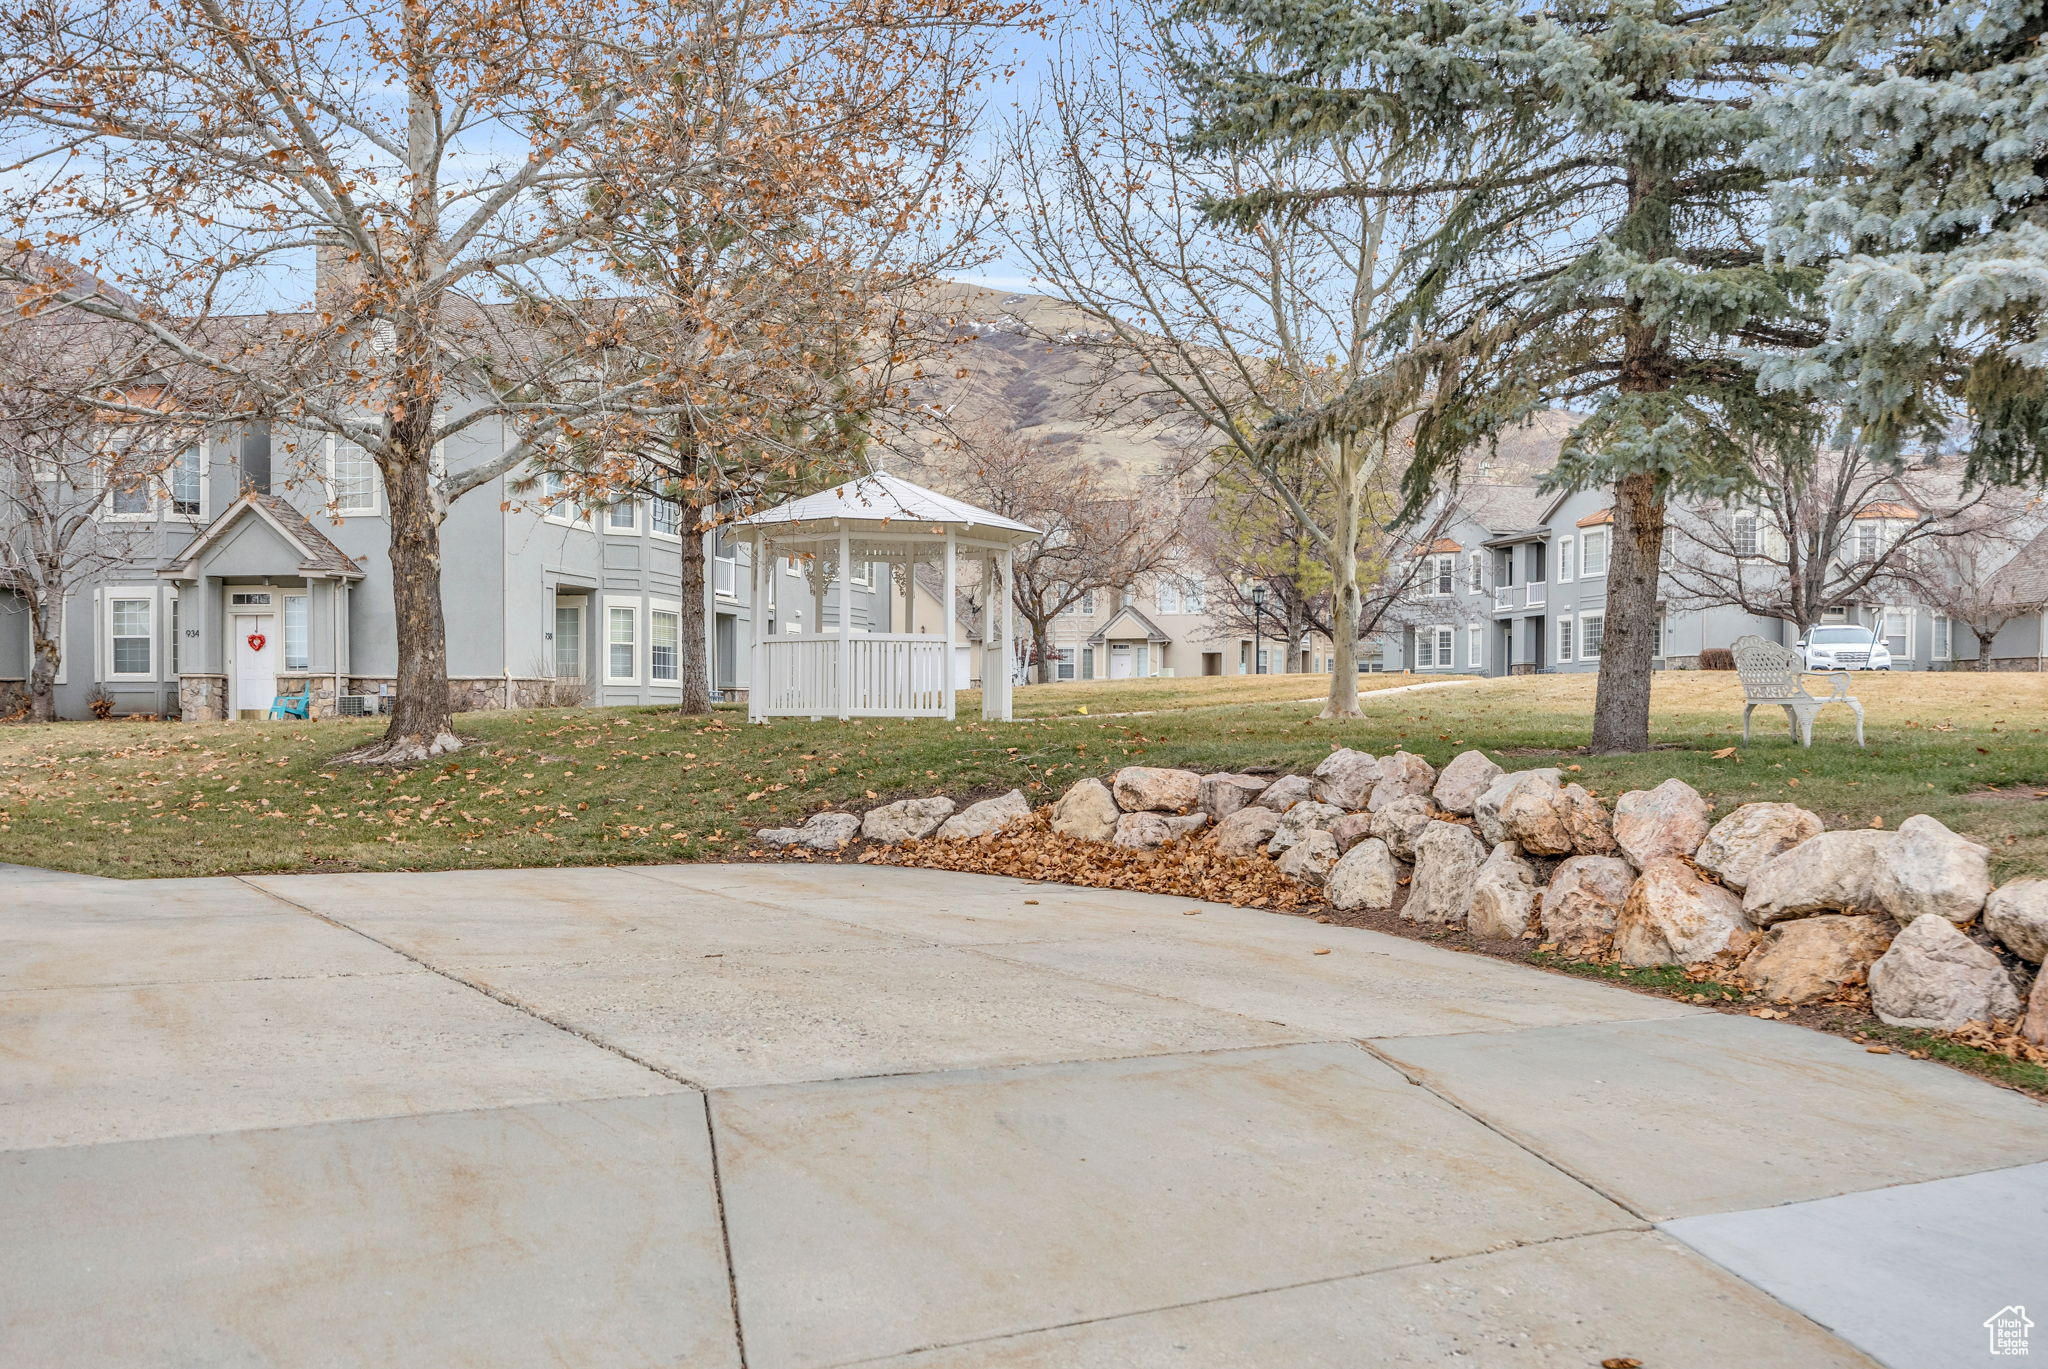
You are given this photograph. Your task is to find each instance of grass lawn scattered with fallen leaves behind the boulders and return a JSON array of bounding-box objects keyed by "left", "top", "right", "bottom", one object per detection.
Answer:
[{"left": 0, "top": 672, "right": 2048, "bottom": 877}]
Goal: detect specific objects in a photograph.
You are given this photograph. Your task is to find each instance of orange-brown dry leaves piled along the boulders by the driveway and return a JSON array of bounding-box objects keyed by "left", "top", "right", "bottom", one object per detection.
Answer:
[{"left": 856, "top": 810, "right": 1323, "bottom": 912}]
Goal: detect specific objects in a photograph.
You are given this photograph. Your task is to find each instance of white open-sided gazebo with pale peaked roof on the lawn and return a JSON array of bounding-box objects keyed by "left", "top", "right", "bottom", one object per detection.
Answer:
[{"left": 733, "top": 475, "right": 1038, "bottom": 721}]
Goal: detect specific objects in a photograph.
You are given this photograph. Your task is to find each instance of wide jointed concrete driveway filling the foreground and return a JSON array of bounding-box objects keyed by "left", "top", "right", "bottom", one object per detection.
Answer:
[{"left": 0, "top": 865, "right": 2048, "bottom": 1369}]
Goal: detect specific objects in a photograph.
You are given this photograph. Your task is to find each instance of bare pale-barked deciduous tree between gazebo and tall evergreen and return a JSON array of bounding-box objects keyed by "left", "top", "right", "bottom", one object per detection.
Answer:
[{"left": 1006, "top": 8, "right": 1427, "bottom": 717}]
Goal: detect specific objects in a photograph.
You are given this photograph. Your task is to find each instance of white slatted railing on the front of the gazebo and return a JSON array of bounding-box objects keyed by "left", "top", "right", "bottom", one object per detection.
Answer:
[{"left": 754, "top": 633, "right": 952, "bottom": 717}]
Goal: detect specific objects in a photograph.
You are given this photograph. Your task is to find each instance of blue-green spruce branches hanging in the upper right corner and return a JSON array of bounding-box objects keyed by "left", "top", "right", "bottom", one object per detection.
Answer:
[{"left": 1753, "top": 0, "right": 2048, "bottom": 484}]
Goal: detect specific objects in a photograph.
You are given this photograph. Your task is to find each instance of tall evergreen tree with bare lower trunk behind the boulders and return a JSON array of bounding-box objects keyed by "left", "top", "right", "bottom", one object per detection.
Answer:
[{"left": 1182, "top": 0, "right": 1819, "bottom": 750}]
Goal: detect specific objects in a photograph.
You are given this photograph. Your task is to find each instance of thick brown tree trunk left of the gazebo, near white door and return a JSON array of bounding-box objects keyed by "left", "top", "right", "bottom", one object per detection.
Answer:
[{"left": 348, "top": 439, "right": 463, "bottom": 764}]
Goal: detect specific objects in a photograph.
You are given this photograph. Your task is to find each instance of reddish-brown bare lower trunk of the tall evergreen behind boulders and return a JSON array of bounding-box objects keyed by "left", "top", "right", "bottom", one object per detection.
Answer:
[{"left": 1593, "top": 471, "right": 1665, "bottom": 752}]
